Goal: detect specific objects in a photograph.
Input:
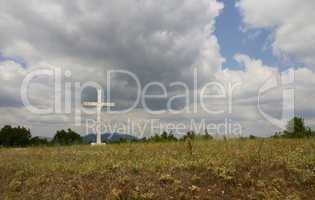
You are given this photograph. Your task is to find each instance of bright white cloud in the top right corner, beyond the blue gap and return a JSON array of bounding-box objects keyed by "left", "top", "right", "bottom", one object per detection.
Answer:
[{"left": 237, "top": 0, "right": 315, "bottom": 70}]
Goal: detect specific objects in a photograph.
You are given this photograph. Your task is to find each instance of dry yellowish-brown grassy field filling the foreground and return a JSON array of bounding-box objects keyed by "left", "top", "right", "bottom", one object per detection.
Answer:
[{"left": 0, "top": 139, "right": 315, "bottom": 200}]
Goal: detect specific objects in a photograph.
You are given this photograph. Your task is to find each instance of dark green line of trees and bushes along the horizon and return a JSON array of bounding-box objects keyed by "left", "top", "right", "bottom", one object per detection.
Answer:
[{"left": 0, "top": 117, "right": 315, "bottom": 147}]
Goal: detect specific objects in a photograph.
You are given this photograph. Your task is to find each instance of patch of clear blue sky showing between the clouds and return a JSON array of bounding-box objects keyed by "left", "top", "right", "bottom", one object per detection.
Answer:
[{"left": 215, "top": 0, "right": 281, "bottom": 69}]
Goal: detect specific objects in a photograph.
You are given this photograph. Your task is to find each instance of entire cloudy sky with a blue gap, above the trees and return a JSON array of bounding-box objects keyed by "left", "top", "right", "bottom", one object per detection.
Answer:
[{"left": 0, "top": 0, "right": 315, "bottom": 137}]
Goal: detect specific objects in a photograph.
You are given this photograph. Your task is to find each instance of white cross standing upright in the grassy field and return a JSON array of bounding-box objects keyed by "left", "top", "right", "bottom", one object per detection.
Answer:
[{"left": 83, "top": 88, "right": 115, "bottom": 145}]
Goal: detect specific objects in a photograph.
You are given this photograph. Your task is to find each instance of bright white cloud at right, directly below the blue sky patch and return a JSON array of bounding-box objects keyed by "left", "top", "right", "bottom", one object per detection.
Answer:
[{"left": 216, "top": 54, "right": 315, "bottom": 135}]
